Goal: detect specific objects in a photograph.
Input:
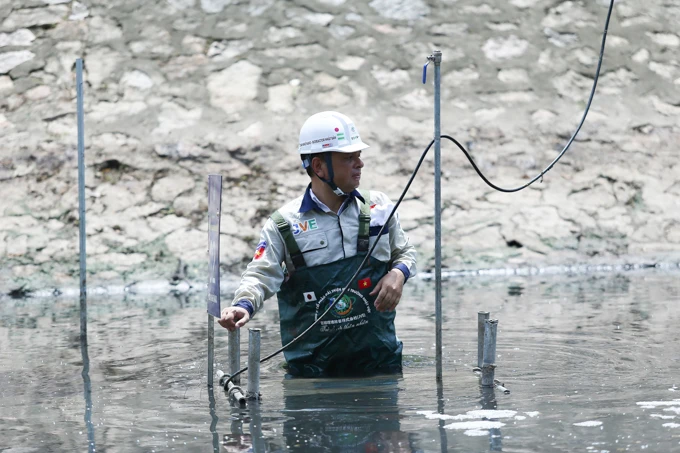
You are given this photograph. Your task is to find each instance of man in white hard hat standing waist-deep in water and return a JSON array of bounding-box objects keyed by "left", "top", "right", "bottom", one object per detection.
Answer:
[{"left": 218, "top": 111, "right": 416, "bottom": 377}]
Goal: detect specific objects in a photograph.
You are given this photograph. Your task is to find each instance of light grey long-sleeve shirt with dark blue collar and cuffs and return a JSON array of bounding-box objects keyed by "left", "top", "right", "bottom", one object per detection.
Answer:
[{"left": 232, "top": 188, "right": 416, "bottom": 314}]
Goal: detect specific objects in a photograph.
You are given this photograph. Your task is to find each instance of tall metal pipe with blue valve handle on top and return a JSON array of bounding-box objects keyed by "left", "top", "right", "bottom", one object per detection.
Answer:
[{"left": 433, "top": 50, "right": 442, "bottom": 381}]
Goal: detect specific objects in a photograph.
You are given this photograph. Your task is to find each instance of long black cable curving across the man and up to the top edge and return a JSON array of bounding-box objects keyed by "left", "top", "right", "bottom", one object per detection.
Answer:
[{"left": 224, "top": 0, "right": 614, "bottom": 388}]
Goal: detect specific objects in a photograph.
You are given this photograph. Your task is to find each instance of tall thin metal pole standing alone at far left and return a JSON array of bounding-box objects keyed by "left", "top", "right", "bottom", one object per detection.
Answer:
[{"left": 76, "top": 58, "right": 87, "bottom": 298}]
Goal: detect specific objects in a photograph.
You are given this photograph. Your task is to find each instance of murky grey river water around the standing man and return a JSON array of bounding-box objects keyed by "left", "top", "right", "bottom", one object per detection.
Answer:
[{"left": 0, "top": 272, "right": 680, "bottom": 453}]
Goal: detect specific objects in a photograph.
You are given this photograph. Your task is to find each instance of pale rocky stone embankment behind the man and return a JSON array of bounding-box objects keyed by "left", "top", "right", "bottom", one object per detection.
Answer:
[{"left": 0, "top": 0, "right": 680, "bottom": 293}]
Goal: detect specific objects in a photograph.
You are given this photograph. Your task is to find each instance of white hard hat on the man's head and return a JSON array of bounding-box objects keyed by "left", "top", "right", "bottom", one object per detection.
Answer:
[{"left": 298, "top": 111, "right": 368, "bottom": 155}]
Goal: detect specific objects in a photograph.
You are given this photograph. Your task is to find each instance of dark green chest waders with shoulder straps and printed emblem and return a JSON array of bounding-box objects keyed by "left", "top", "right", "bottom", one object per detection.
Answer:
[{"left": 271, "top": 193, "right": 402, "bottom": 377}]
